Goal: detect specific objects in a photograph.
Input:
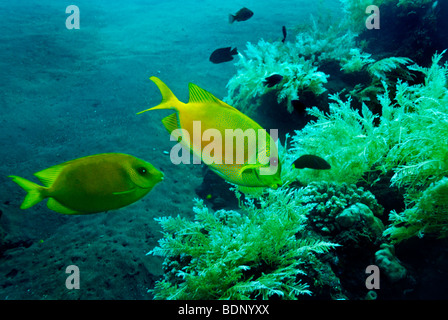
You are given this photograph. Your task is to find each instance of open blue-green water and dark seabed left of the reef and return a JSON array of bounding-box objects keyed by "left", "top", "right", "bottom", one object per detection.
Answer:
[{"left": 0, "top": 0, "right": 446, "bottom": 299}]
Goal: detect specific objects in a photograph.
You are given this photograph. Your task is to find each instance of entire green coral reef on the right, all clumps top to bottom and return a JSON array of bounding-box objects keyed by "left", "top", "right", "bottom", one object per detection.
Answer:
[{"left": 149, "top": 0, "right": 448, "bottom": 299}]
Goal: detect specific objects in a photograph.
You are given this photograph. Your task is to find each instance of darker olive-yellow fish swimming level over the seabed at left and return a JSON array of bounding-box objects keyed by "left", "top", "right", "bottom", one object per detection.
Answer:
[{"left": 9, "top": 153, "right": 163, "bottom": 214}]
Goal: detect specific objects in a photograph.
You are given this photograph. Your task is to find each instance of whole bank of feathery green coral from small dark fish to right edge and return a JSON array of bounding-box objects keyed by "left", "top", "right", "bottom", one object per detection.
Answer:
[{"left": 289, "top": 53, "right": 448, "bottom": 241}]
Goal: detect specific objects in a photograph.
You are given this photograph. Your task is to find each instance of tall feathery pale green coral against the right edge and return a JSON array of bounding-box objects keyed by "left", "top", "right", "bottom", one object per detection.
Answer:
[{"left": 385, "top": 53, "right": 448, "bottom": 190}]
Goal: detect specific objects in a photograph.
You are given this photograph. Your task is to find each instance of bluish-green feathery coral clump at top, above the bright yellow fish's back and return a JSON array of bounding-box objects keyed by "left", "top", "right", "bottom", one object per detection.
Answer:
[{"left": 226, "top": 20, "right": 366, "bottom": 113}]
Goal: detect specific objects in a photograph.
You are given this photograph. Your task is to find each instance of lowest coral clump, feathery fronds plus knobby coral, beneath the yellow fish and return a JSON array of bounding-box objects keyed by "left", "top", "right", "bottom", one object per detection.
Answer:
[{"left": 149, "top": 182, "right": 390, "bottom": 299}]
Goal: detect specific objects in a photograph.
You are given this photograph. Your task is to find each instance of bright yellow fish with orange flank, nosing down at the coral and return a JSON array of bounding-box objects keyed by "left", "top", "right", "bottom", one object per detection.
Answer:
[{"left": 139, "top": 77, "right": 282, "bottom": 188}]
